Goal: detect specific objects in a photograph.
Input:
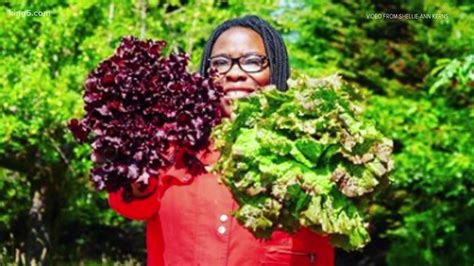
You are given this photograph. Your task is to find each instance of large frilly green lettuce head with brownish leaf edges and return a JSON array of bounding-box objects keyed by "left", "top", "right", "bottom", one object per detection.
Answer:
[{"left": 213, "top": 75, "right": 393, "bottom": 250}]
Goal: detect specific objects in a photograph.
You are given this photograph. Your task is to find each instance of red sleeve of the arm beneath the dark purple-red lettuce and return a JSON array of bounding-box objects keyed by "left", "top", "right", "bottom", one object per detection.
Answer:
[{"left": 109, "top": 178, "right": 162, "bottom": 220}]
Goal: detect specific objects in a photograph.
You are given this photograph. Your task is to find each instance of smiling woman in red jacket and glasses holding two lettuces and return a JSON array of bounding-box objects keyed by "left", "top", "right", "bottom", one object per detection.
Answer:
[{"left": 109, "top": 16, "right": 334, "bottom": 266}]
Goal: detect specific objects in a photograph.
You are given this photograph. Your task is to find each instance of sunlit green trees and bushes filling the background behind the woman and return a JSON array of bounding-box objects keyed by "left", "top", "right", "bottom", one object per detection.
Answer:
[{"left": 0, "top": 0, "right": 474, "bottom": 265}]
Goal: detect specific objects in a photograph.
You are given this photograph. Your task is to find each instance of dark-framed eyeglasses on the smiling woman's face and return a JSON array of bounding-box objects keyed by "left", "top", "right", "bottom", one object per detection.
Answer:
[{"left": 209, "top": 54, "right": 268, "bottom": 74}]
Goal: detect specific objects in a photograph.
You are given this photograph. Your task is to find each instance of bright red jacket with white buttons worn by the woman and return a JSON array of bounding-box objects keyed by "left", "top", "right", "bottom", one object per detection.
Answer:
[{"left": 109, "top": 147, "right": 334, "bottom": 266}]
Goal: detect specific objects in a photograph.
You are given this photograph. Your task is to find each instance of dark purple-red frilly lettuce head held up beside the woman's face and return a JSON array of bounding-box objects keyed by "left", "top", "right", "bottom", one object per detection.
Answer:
[{"left": 68, "top": 37, "right": 223, "bottom": 200}]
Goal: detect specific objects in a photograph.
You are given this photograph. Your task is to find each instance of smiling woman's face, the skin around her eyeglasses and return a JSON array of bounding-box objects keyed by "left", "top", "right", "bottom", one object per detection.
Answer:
[{"left": 211, "top": 27, "right": 270, "bottom": 99}]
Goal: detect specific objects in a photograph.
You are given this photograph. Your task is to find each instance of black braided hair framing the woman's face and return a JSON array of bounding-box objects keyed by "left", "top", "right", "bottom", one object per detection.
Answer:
[{"left": 199, "top": 15, "right": 290, "bottom": 91}]
